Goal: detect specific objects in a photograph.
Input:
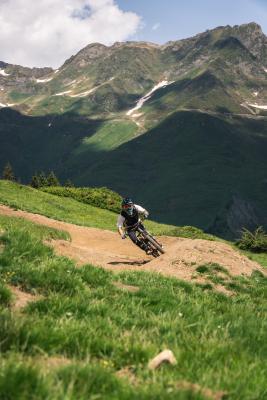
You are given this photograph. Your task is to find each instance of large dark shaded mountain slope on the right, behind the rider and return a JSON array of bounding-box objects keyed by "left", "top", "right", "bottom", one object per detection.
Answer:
[{"left": 77, "top": 112, "right": 267, "bottom": 237}]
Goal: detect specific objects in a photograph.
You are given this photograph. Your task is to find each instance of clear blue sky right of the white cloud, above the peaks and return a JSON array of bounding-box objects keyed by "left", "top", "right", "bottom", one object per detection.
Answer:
[{"left": 117, "top": 0, "right": 267, "bottom": 43}]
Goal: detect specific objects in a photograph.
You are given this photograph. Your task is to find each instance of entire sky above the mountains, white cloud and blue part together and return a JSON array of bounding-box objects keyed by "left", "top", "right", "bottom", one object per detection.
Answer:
[{"left": 0, "top": 0, "right": 267, "bottom": 68}]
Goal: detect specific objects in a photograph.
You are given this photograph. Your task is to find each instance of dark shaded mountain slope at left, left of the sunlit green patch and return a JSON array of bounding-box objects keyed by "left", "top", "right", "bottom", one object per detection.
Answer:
[{"left": 0, "top": 109, "right": 103, "bottom": 182}]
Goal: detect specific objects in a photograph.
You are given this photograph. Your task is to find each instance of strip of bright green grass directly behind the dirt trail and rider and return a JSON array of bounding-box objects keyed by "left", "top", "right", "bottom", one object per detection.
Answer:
[{"left": 0, "top": 180, "right": 216, "bottom": 240}]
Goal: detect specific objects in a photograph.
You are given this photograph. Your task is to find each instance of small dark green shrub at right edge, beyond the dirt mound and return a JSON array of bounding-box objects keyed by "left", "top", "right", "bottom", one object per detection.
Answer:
[{"left": 236, "top": 226, "right": 267, "bottom": 253}]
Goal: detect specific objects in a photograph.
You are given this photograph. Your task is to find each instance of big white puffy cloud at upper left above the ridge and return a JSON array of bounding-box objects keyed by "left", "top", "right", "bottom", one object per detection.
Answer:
[{"left": 0, "top": 0, "right": 141, "bottom": 67}]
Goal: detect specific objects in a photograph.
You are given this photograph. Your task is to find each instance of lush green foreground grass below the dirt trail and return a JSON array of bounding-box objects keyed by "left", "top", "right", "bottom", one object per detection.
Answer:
[{"left": 0, "top": 217, "right": 267, "bottom": 400}]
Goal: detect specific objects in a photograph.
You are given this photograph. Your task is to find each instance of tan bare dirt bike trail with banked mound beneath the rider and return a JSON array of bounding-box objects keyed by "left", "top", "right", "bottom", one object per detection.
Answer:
[{"left": 0, "top": 205, "right": 266, "bottom": 282}]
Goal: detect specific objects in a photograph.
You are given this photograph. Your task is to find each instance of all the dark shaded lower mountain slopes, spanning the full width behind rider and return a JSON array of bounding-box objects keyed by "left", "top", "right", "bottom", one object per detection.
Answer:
[{"left": 0, "top": 107, "right": 267, "bottom": 239}]
